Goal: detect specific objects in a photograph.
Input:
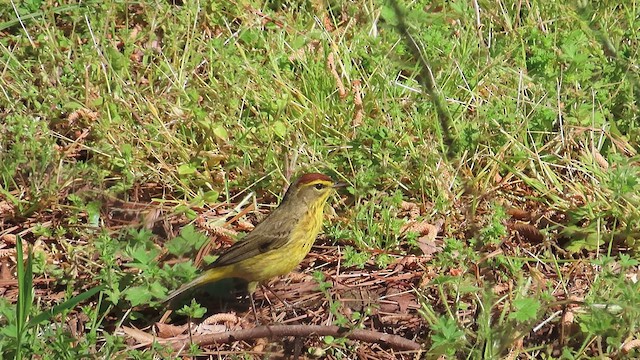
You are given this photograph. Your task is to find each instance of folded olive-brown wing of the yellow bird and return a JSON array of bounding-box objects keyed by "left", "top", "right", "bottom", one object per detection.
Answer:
[{"left": 205, "top": 215, "right": 292, "bottom": 270}]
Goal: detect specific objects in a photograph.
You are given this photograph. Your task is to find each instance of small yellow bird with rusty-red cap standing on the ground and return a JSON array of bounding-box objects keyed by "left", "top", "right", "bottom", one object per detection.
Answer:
[{"left": 164, "top": 173, "right": 346, "bottom": 305}]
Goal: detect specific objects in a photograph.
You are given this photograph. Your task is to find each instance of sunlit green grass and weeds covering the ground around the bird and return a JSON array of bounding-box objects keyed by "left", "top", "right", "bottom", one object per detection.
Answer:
[{"left": 0, "top": 0, "right": 640, "bottom": 359}]
